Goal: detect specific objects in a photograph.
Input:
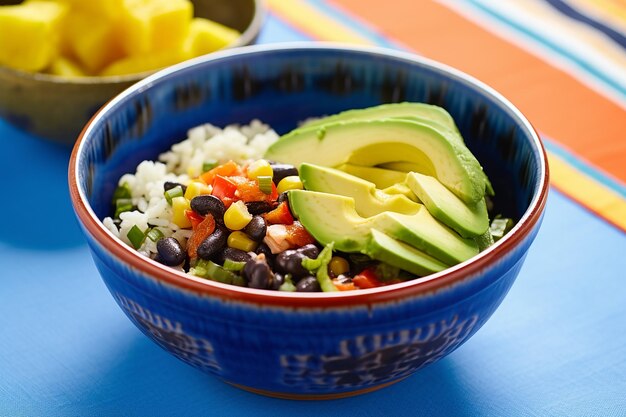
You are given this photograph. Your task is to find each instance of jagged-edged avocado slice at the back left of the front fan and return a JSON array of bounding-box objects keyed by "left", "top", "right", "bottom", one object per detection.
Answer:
[{"left": 299, "top": 163, "right": 423, "bottom": 217}]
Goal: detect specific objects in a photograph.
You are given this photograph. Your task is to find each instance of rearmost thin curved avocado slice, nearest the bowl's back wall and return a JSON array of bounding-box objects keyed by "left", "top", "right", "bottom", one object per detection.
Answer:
[{"left": 304, "top": 102, "right": 462, "bottom": 134}]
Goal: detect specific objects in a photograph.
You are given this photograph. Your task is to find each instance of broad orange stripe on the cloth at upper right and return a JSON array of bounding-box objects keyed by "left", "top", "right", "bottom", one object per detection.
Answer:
[{"left": 333, "top": 0, "right": 626, "bottom": 183}]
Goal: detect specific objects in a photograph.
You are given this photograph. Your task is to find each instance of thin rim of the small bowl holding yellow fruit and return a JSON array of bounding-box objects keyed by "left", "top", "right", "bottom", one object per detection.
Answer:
[{"left": 0, "top": 0, "right": 267, "bottom": 86}]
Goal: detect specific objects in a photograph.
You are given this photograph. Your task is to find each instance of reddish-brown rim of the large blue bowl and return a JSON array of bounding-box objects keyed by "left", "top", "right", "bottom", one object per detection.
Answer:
[{"left": 68, "top": 42, "right": 549, "bottom": 308}]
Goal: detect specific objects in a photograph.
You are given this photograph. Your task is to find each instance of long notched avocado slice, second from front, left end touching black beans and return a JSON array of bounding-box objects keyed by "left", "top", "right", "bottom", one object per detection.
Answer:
[{"left": 288, "top": 190, "right": 478, "bottom": 265}]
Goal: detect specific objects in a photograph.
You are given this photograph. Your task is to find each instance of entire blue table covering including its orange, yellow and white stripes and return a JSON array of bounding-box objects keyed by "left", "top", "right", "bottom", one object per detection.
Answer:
[{"left": 0, "top": 0, "right": 626, "bottom": 416}]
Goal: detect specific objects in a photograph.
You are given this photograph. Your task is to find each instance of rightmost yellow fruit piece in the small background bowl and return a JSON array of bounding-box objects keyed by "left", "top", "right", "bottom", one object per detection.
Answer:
[{"left": 184, "top": 17, "right": 241, "bottom": 57}]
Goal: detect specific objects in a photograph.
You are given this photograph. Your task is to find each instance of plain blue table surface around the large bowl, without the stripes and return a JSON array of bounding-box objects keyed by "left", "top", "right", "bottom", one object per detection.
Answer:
[{"left": 0, "top": 16, "right": 626, "bottom": 416}]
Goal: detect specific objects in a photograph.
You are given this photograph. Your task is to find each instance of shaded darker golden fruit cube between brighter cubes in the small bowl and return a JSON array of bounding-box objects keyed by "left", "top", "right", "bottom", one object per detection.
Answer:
[{"left": 64, "top": 11, "right": 124, "bottom": 74}]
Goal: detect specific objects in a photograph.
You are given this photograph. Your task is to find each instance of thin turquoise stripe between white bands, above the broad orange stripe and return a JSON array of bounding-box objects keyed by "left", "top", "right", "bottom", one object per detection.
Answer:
[{"left": 465, "top": 0, "right": 626, "bottom": 99}]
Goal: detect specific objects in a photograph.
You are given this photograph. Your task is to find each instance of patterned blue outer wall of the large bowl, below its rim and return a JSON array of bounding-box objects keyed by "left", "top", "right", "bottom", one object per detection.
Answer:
[{"left": 83, "top": 224, "right": 532, "bottom": 396}]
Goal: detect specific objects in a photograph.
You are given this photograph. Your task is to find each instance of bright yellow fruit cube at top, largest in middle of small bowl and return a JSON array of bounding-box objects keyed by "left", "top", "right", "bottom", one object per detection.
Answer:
[{"left": 122, "top": 0, "right": 193, "bottom": 55}]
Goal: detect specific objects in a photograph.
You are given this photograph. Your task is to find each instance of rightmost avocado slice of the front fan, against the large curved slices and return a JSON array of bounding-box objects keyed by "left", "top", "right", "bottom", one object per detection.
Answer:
[{"left": 406, "top": 172, "right": 489, "bottom": 238}]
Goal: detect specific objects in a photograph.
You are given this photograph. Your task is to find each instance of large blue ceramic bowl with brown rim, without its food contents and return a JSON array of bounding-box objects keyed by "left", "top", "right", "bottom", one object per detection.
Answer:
[{"left": 69, "top": 44, "right": 548, "bottom": 398}]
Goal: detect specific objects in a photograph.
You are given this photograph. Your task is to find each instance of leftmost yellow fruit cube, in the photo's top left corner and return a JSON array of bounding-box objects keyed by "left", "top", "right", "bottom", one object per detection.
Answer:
[{"left": 0, "top": 0, "right": 67, "bottom": 71}]
